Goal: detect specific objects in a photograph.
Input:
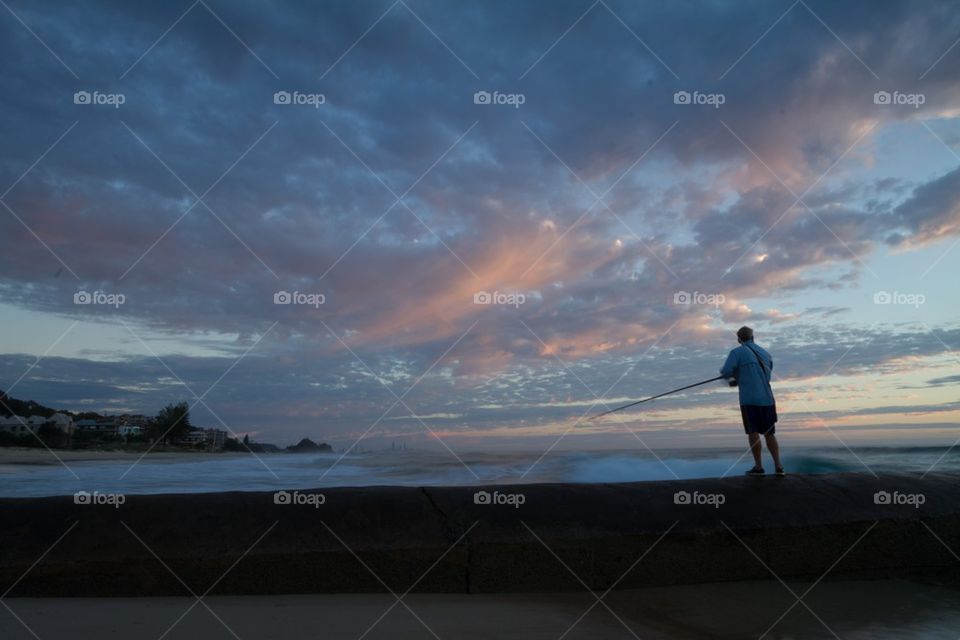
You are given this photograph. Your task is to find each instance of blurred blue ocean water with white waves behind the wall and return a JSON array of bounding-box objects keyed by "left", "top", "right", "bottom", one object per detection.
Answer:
[{"left": 0, "top": 447, "right": 960, "bottom": 497}]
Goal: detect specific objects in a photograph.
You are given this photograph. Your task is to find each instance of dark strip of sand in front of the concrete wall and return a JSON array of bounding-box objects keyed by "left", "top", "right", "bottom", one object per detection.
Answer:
[{"left": 0, "top": 580, "right": 960, "bottom": 640}]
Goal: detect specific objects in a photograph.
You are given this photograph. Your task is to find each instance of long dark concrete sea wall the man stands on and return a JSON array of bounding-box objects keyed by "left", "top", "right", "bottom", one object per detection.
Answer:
[{"left": 0, "top": 474, "right": 960, "bottom": 596}]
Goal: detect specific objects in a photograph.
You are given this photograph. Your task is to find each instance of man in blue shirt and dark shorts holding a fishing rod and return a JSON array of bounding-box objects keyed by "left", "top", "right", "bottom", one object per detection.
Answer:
[{"left": 720, "top": 327, "right": 783, "bottom": 476}]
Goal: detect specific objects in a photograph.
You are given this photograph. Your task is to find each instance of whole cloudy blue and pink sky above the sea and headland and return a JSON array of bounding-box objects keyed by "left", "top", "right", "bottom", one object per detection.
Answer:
[{"left": 0, "top": 0, "right": 960, "bottom": 452}]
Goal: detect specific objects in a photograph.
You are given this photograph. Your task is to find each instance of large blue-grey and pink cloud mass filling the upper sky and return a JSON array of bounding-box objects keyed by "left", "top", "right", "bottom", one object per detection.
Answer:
[{"left": 0, "top": 2, "right": 960, "bottom": 444}]
